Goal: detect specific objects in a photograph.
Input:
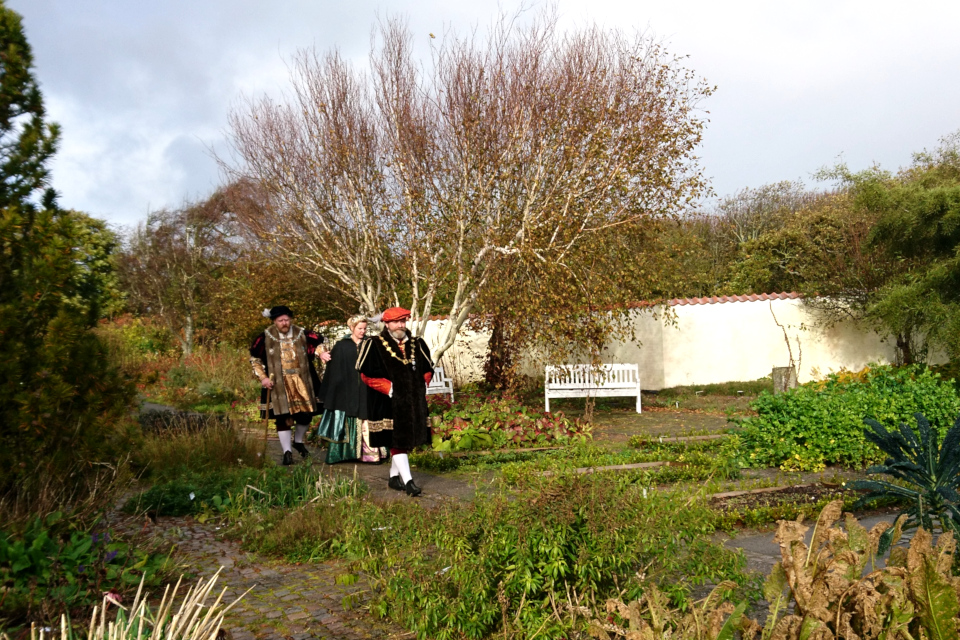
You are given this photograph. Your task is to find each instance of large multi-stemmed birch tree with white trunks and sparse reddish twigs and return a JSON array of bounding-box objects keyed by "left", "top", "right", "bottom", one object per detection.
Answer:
[{"left": 229, "top": 13, "right": 711, "bottom": 358}]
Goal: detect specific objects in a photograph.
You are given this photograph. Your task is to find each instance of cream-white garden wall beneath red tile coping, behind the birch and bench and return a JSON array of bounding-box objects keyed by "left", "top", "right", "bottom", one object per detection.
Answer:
[{"left": 425, "top": 294, "right": 928, "bottom": 390}]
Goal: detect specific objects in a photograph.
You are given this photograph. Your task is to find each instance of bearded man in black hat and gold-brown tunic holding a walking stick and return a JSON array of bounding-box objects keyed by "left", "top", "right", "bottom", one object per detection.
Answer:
[{"left": 250, "top": 305, "right": 330, "bottom": 465}]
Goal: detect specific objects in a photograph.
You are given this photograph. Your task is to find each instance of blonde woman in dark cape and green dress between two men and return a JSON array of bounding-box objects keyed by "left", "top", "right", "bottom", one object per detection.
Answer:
[{"left": 317, "top": 316, "right": 387, "bottom": 464}]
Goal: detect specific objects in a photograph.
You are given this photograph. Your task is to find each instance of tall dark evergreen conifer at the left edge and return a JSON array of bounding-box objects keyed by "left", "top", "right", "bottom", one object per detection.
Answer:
[{"left": 0, "top": 0, "right": 130, "bottom": 503}]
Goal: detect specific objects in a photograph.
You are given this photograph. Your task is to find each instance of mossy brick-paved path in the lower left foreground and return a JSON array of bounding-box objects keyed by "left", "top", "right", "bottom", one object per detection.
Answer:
[{"left": 113, "top": 517, "right": 413, "bottom": 640}]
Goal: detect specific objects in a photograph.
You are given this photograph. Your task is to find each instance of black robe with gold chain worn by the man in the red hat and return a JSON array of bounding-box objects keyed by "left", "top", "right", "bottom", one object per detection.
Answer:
[{"left": 357, "top": 329, "right": 433, "bottom": 449}]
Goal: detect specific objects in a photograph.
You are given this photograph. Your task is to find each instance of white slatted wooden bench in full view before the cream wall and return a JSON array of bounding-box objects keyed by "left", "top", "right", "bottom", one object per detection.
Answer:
[{"left": 544, "top": 364, "right": 640, "bottom": 413}]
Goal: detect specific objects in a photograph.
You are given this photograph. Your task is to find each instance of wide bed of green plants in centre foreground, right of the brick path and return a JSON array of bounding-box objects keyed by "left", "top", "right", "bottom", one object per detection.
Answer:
[{"left": 242, "top": 476, "right": 748, "bottom": 638}]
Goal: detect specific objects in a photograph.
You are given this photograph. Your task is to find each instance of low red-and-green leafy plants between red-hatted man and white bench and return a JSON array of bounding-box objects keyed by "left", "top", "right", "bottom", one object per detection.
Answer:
[{"left": 432, "top": 393, "right": 591, "bottom": 451}]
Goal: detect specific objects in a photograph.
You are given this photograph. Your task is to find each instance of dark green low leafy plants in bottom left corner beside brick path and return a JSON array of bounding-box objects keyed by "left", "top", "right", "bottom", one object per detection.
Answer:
[{"left": 0, "top": 512, "right": 169, "bottom": 624}]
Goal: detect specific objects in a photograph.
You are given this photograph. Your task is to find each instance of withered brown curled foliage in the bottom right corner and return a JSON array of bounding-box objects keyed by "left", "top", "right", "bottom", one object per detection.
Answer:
[{"left": 587, "top": 500, "right": 960, "bottom": 640}]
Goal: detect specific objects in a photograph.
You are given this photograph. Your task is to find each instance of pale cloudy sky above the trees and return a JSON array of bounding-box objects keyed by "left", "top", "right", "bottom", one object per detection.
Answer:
[{"left": 13, "top": 0, "right": 960, "bottom": 225}]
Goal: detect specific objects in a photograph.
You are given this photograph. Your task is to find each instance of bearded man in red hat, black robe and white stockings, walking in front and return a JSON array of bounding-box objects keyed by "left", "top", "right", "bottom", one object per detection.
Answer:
[{"left": 357, "top": 307, "right": 433, "bottom": 496}]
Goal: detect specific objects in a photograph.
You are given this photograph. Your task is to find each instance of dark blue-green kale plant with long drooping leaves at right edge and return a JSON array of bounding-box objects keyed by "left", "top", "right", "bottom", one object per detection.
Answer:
[{"left": 851, "top": 413, "right": 960, "bottom": 553}]
